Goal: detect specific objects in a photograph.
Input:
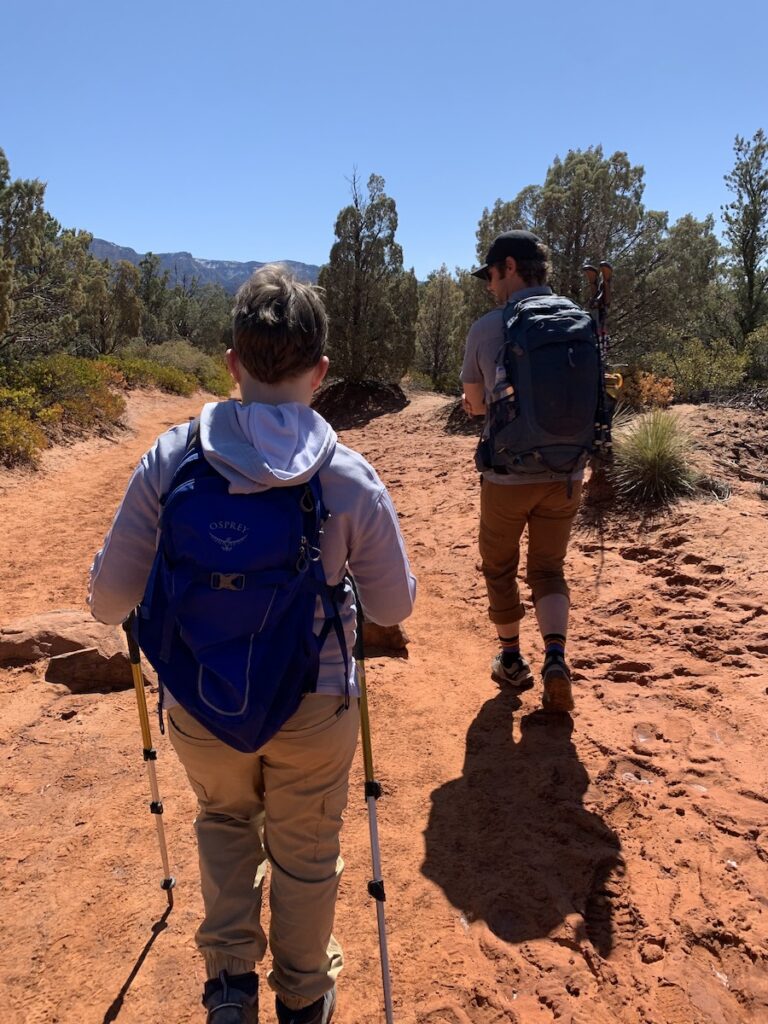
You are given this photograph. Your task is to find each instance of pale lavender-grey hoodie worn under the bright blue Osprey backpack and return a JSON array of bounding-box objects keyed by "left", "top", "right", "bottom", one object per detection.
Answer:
[{"left": 88, "top": 399, "right": 416, "bottom": 705}]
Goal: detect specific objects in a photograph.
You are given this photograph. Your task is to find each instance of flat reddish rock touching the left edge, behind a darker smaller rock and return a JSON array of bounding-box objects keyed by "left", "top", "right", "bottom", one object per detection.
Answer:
[{"left": 0, "top": 608, "right": 125, "bottom": 665}]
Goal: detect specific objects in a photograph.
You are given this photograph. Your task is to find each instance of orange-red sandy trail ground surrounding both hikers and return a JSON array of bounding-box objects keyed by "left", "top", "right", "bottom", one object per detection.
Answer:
[{"left": 0, "top": 387, "right": 768, "bottom": 1024}]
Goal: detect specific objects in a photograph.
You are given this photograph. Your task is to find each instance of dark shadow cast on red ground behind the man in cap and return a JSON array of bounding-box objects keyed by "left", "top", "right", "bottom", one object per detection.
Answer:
[{"left": 422, "top": 690, "right": 623, "bottom": 956}]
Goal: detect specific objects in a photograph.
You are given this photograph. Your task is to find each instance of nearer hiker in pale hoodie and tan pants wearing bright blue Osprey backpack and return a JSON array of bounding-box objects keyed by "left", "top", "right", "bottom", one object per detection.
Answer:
[{"left": 89, "top": 265, "right": 416, "bottom": 1024}]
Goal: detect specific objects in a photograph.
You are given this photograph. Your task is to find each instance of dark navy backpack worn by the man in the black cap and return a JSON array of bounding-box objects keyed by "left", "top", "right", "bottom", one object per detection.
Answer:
[{"left": 475, "top": 295, "right": 610, "bottom": 482}]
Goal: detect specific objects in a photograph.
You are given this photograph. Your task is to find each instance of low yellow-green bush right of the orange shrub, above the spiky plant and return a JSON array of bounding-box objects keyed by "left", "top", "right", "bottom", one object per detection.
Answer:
[{"left": 651, "top": 338, "right": 750, "bottom": 401}]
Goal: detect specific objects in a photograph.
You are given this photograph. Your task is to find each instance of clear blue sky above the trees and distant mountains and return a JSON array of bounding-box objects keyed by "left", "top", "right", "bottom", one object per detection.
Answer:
[{"left": 0, "top": 0, "right": 768, "bottom": 279}]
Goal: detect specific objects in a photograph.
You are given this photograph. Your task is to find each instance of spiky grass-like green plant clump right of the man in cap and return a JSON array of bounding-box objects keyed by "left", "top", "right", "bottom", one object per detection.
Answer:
[{"left": 611, "top": 409, "right": 696, "bottom": 506}]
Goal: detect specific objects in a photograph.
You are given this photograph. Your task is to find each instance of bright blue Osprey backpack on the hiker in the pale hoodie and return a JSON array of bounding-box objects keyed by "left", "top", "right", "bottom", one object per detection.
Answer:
[{"left": 135, "top": 421, "right": 349, "bottom": 752}]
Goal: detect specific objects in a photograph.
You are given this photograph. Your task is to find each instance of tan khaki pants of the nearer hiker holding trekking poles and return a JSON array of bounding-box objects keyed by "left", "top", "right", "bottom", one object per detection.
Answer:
[{"left": 168, "top": 693, "right": 359, "bottom": 1010}]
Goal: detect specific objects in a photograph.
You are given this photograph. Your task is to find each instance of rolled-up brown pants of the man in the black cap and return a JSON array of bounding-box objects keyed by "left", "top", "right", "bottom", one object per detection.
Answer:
[{"left": 479, "top": 480, "right": 582, "bottom": 625}]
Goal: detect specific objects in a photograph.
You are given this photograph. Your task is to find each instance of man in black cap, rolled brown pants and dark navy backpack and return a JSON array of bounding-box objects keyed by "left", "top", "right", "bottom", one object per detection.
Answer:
[{"left": 461, "top": 230, "right": 610, "bottom": 712}]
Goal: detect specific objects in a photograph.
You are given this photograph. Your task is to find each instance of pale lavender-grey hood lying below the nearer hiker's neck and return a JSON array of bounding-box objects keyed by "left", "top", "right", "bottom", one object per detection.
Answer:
[{"left": 200, "top": 399, "right": 336, "bottom": 495}]
